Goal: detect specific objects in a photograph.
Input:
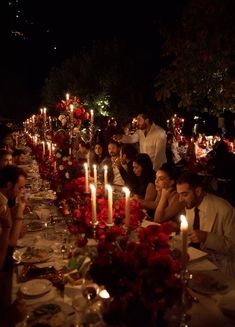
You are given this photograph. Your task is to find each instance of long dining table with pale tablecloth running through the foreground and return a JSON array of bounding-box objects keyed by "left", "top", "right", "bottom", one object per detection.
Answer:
[{"left": 7, "top": 162, "right": 235, "bottom": 327}]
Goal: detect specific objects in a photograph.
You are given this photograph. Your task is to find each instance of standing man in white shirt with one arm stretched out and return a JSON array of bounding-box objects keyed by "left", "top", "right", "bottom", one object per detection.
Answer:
[{"left": 113, "top": 113, "right": 167, "bottom": 171}]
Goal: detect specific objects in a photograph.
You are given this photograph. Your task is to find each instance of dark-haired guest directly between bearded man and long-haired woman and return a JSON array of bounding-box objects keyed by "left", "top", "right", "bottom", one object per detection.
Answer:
[{"left": 119, "top": 144, "right": 138, "bottom": 193}]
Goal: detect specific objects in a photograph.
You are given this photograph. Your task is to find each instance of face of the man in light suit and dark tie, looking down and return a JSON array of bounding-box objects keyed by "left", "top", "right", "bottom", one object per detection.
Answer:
[{"left": 176, "top": 183, "right": 202, "bottom": 209}]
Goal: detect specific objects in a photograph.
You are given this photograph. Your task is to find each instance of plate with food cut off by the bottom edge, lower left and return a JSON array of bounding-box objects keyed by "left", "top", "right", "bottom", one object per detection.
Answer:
[{"left": 27, "top": 302, "right": 74, "bottom": 327}]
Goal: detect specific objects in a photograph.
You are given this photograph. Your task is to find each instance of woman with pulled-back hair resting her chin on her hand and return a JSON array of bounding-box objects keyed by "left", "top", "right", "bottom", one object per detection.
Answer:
[{"left": 154, "top": 164, "right": 184, "bottom": 223}]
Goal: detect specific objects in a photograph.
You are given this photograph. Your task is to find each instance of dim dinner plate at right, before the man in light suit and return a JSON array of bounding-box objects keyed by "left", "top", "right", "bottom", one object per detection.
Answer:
[{"left": 189, "top": 271, "right": 229, "bottom": 295}]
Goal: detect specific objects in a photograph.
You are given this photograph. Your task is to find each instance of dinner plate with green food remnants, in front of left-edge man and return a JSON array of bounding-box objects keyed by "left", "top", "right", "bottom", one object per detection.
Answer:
[{"left": 13, "top": 246, "right": 53, "bottom": 263}]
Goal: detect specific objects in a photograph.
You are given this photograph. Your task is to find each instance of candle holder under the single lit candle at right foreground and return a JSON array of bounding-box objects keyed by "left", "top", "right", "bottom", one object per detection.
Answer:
[{"left": 179, "top": 267, "right": 192, "bottom": 327}]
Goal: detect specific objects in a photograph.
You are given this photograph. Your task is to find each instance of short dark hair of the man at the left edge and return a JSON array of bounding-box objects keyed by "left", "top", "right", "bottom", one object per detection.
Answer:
[{"left": 0, "top": 165, "right": 27, "bottom": 187}]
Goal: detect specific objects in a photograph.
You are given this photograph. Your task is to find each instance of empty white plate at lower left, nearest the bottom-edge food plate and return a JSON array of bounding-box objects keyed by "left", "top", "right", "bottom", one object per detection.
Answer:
[{"left": 20, "top": 279, "right": 52, "bottom": 296}]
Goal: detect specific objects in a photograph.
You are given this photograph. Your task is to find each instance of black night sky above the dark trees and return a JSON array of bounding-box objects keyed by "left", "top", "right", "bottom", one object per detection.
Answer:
[{"left": 1, "top": 0, "right": 181, "bottom": 117}]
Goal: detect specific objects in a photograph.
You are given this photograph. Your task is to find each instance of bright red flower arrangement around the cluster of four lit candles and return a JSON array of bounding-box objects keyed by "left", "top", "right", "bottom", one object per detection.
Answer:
[{"left": 59, "top": 177, "right": 145, "bottom": 245}]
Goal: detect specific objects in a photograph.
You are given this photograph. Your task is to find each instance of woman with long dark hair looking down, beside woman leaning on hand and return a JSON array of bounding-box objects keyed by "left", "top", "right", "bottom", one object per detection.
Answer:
[{"left": 133, "top": 153, "right": 156, "bottom": 201}]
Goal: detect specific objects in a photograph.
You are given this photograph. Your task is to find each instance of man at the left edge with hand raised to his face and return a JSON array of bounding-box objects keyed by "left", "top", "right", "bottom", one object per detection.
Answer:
[{"left": 0, "top": 165, "right": 26, "bottom": 271}]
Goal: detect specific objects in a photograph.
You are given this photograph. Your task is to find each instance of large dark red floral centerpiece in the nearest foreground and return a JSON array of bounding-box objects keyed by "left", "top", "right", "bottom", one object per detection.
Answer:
[{"left": 90, "top": 223, "right": 182, "bottom": 327}]
